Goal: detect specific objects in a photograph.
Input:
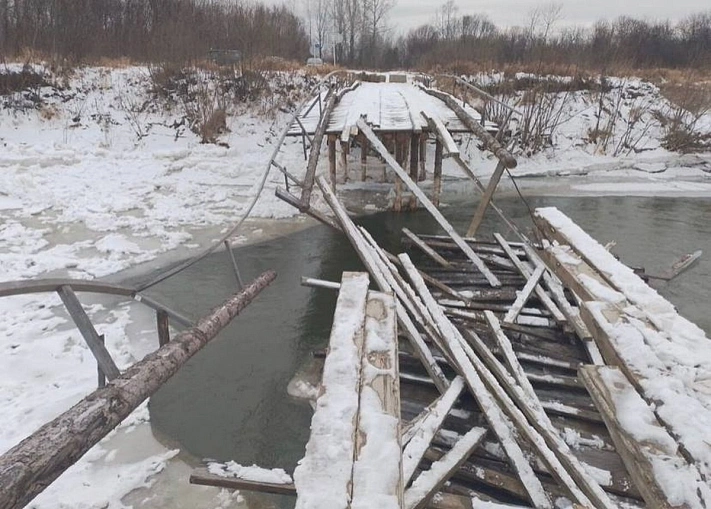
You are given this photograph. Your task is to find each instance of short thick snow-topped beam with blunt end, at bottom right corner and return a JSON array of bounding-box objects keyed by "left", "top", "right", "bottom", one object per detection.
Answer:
[{"left": 580, "top": 366, "right": 711, "bottom": 509}]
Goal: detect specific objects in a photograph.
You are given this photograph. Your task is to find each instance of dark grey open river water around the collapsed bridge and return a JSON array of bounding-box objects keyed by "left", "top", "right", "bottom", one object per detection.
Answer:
[{"left": 143, "top": 197, "right": 711, "bottom": 471}]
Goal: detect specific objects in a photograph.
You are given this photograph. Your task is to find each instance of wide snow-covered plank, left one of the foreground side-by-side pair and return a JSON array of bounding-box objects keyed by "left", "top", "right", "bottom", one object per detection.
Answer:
[{"left": 294, "top": 272, "right": 369, "bottom": 509}]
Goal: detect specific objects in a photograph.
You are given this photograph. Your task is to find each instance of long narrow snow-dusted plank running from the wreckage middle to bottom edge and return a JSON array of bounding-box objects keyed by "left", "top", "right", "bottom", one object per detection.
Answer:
[{"left": 399, "top": 254, "right": 552, "bottom": 508}]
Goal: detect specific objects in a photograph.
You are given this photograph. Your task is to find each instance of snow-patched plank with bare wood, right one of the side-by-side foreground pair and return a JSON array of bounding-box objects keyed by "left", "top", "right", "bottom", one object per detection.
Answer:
[{"left": 350, "top": 292, "right": 403, "bottom": 509}]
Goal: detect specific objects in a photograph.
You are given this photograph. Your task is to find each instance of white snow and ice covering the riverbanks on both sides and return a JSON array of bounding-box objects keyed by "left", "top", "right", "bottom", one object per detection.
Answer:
[{"left": 0, "top": 67, "right": 711, "bottom": 508}]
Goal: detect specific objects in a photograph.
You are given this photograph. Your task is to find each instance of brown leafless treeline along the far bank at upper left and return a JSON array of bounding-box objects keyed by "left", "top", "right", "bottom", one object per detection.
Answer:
[{"left": 0, "top": 0, "right": 309, "bottom": 62}]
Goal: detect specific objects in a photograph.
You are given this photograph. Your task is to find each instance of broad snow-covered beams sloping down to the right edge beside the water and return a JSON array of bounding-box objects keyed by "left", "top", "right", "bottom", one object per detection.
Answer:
[{"left": 539, "top": 209, "right": 711, "bottom": 480}]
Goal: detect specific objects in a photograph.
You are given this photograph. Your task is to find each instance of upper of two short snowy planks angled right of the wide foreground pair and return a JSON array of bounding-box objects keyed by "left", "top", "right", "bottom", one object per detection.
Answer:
[{"left": 402, "top": 376, "right": 464, "bottom": 484}]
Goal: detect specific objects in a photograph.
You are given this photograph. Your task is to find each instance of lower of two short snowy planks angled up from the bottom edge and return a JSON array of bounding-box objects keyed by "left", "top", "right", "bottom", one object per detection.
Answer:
[{"left": 404, "top": 428, "right": 486, "bottom": 509}]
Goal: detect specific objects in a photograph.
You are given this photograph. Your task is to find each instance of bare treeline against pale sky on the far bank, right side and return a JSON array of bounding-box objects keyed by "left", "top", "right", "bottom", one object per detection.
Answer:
[{"left": 398, "top": 2, "right": 711, "bottom": 69}]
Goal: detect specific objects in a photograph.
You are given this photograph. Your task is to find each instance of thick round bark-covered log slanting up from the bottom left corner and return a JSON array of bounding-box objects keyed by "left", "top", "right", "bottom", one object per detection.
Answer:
[{"left": 0, "top": 271, "right": 276, "bottom": 509}]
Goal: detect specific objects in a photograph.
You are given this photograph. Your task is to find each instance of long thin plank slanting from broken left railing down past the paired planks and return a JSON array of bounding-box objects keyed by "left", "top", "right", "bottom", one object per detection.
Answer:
[{"left": 316, "top": 176, "right": 449, "bottom": 393}]
